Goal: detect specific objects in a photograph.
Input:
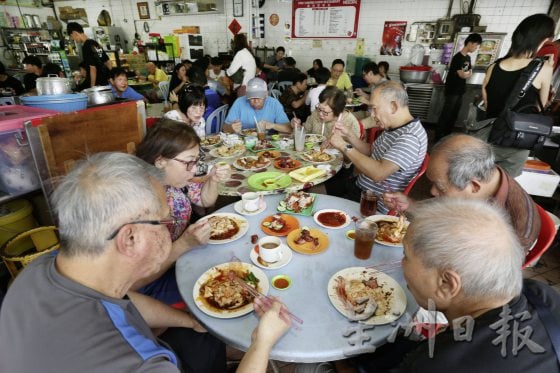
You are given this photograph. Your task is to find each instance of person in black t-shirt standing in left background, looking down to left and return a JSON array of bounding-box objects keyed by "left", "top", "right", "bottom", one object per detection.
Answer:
[{"left": 66, "top": 22, "right": 112, "bottom": 87}]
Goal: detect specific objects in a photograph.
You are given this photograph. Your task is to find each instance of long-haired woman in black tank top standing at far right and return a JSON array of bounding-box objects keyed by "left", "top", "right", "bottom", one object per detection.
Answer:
[{"left": 477, "top": 14, "right": 555, "bottom": 177}]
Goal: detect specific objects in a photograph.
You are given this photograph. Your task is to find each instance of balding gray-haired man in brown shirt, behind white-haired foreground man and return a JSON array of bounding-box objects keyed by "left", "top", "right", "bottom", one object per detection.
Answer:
[{"left": 384, "top": 134, "right": 541, "bottom": 252}]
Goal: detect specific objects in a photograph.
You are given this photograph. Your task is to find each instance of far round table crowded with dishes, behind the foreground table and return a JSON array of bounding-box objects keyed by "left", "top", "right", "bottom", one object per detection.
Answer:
[{"left": 204, "top": 140, "right": 344, "bottom": 197}]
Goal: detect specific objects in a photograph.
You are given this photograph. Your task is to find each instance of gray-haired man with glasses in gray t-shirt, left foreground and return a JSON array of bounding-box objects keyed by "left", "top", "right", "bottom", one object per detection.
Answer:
[{"left": 0, "top": 153, "right": 288, "bottom": 372}]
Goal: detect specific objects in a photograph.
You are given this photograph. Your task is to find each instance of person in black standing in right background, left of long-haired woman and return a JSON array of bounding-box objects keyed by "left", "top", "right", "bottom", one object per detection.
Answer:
[{"left": 435, "top": 33, "right": 482, "bottom": 141}]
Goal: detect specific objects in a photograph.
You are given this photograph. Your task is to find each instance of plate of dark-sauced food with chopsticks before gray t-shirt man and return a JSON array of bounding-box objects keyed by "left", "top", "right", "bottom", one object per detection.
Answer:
[{"left": 193, "top": 262, "right": 269, "bottom": 319}]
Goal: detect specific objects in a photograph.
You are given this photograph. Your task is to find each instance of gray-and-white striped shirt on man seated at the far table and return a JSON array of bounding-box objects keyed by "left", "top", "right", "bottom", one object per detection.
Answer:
[{"left": 356, "top": 119, "right": 428, "bottom": 214}]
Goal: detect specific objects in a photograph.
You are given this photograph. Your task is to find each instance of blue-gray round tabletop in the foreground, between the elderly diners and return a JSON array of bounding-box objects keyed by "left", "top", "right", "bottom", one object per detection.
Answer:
[{"left": 176, "top": 195, "right": 418, "bottom": 363}]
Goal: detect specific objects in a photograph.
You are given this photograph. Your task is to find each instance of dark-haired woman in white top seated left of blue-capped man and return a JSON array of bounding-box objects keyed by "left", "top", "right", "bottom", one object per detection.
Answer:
[{"left": 163, "top": 84, "right": 206, "bottom": 138}]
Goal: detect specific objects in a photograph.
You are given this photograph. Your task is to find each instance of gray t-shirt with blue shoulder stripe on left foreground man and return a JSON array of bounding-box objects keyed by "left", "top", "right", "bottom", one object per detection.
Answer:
[{"left": 0, "top": 255, "right": 179, "bottom": 373}]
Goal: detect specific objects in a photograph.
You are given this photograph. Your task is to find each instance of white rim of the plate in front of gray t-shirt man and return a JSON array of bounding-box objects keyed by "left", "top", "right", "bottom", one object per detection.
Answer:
[{"left": 193, "top": 263, "right": 270, "bottom": 319}]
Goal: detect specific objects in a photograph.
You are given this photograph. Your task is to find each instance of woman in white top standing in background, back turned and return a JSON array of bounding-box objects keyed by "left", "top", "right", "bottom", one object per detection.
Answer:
[{"left": 226, "top": 34, "right": 257, "bottom": 97}]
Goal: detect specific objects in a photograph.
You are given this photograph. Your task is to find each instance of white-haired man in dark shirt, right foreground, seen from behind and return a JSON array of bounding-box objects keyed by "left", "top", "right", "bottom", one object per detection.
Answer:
[{"left": 358, "top": 198, "right": 560, "bottom": 373}]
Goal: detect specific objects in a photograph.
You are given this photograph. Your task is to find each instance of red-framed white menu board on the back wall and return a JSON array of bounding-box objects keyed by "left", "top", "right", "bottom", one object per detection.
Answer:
[{"left": 292, "top": 0, "right": 360, "bottom": 39}]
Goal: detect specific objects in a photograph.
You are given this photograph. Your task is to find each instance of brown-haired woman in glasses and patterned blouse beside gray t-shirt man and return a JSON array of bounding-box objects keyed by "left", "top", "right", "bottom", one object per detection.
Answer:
[{"left": 136, "top": 118, "right": 231, "bottom": 305}]
